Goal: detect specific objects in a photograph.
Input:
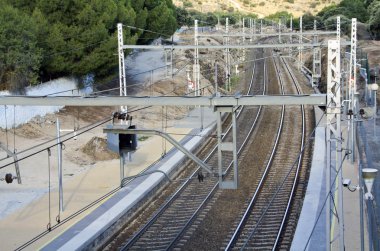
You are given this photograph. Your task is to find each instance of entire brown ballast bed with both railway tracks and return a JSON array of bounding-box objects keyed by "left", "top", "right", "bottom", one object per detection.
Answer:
[{"left": 102, "top": 42, "right": 314, "bottom": 250}]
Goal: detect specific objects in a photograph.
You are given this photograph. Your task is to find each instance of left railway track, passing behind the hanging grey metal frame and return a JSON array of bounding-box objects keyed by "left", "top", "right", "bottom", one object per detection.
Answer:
[{"left": 103, "top": 47, "right": 265, "bottom": 250}]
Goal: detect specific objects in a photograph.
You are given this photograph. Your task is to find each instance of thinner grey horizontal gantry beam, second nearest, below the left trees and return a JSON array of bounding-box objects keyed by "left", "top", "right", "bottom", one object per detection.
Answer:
[{"left": 123, "top": 41, "right": 351, "bottom": 50}]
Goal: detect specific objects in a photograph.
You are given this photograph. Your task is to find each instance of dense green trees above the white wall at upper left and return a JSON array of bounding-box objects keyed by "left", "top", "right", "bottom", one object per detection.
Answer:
[{"left": 0, "top": 0, "right": 177, "bottom": 89}]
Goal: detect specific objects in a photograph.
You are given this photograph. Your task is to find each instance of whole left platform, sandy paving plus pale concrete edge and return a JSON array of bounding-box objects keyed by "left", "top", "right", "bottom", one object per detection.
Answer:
[{"left": 0, "top": 108, "right": 215, "bottom": 250}]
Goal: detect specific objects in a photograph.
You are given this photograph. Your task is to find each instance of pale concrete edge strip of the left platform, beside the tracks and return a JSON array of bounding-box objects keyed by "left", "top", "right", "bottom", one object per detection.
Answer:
[{"left": 41, "top": 127, "right": 212, "bottom": 251}]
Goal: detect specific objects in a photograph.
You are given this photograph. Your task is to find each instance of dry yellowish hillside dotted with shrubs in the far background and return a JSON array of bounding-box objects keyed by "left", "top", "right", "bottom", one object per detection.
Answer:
[{"left": 173, "top": 0, "right": 339, "bottom": 18}]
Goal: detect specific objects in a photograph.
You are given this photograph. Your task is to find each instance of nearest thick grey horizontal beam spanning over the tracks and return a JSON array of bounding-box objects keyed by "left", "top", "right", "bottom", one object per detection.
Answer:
[{"left": 0, "top": 94, "right": 326, "bottom": 106}]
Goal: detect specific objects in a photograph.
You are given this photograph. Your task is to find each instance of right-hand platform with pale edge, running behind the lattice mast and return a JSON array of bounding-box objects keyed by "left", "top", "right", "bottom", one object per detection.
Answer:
[{"left": 291, "top": 107, "right": 374, "bottom": 250}]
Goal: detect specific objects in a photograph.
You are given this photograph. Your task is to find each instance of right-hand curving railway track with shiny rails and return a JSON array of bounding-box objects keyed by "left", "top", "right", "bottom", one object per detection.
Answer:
[{"left": 226, "top": 49, "right": 305, "bottom": 250}]
